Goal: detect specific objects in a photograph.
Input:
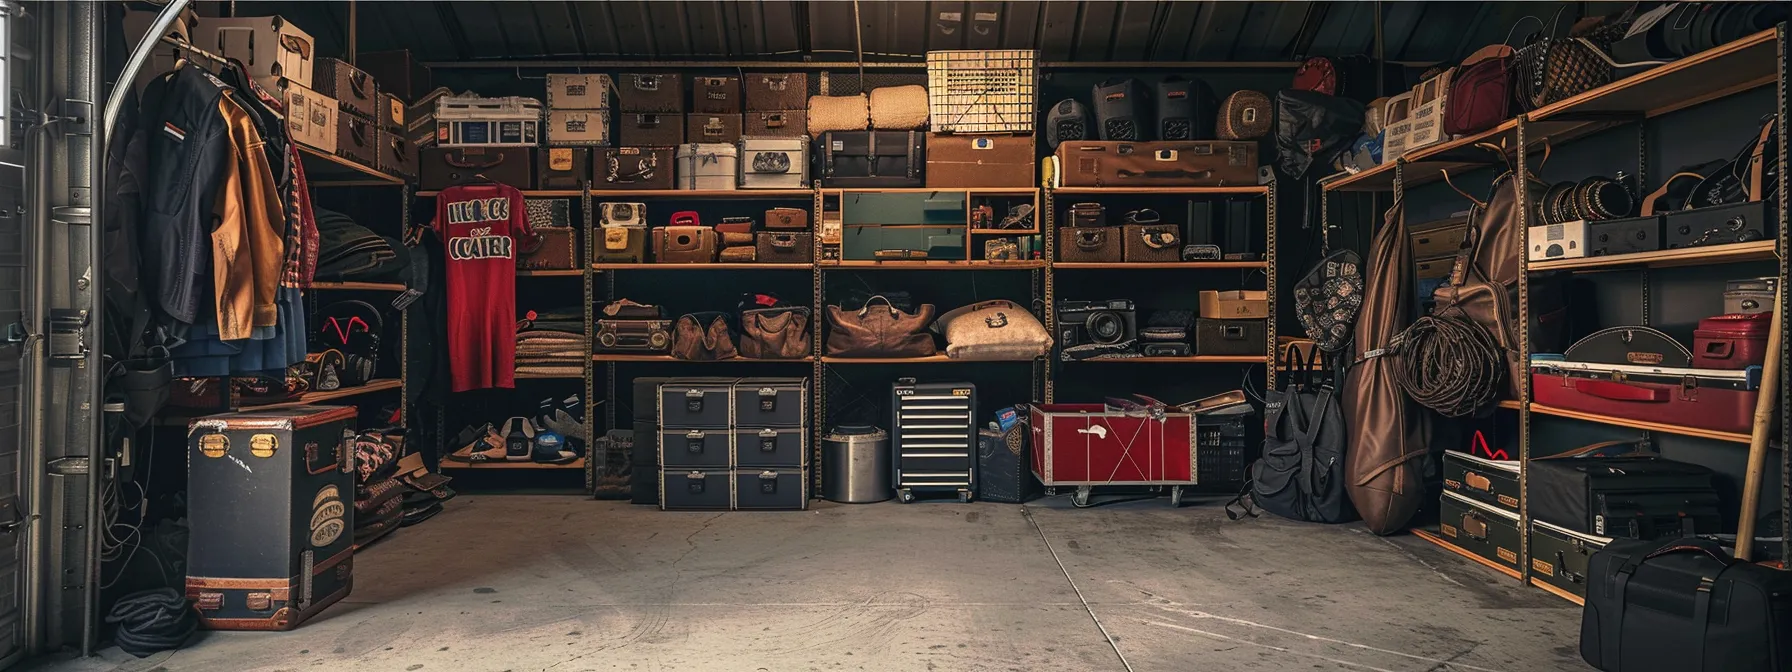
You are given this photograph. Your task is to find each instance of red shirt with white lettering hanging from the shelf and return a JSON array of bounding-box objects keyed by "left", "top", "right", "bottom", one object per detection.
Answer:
[{"left": 434, "top": 185, "right": 541, "bottom": 392}]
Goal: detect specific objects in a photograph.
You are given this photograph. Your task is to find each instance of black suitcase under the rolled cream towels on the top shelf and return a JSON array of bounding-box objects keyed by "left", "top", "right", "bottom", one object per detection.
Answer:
[{"left": 810, "top": 131, "right": 926, "bottom": 188}]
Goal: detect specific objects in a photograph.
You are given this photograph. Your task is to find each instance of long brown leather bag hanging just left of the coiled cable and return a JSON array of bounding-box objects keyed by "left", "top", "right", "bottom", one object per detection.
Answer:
[{"left": 1344, "top": 194, "right": 1432, "bottom": 534}]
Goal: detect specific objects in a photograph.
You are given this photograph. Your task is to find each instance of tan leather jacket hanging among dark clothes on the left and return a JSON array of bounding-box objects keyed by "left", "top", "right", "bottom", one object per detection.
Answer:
[{"left": 211, "top": 95, "right": 287, "bottom": 340}]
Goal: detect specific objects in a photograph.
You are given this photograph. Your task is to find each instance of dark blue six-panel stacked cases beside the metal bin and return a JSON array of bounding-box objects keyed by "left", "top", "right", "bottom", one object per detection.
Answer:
[{"left": 656, "top": 378, "right": 810, "bottom": 511}]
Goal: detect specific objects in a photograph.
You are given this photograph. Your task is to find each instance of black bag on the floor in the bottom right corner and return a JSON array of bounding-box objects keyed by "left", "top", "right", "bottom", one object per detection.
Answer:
[{"left": 1581, "top": 538, "right": 1792, "bottom": 672}]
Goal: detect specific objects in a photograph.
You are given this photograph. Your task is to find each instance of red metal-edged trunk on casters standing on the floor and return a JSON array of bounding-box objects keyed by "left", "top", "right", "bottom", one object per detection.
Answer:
[{"left": 1027, "top": 403, "right": 1199, "bottom": 487}]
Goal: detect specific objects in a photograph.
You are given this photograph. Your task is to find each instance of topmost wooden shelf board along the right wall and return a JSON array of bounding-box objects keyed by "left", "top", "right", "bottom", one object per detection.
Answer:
[{"left": 1319, "top": 30, "right": 1778, "bottom": 192}]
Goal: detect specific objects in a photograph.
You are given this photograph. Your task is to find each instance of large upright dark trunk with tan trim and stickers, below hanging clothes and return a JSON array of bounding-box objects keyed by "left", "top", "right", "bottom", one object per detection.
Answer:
[{"left": 186, "top": 407, "right": 355, "bottom": 631}]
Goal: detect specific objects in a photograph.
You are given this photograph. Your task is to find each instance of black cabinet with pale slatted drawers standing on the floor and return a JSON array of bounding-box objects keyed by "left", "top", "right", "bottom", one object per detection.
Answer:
[{"left": 891, "top": 378, "right": 977, "bottom": 502}]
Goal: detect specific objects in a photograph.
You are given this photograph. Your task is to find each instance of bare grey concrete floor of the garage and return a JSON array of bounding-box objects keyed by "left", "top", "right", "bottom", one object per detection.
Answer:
[{"left": 27, "top": 495, "right": 1586, "bottom": 672}]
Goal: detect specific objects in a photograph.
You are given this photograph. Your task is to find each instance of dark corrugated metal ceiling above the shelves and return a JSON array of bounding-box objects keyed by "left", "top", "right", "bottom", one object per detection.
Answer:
[{"left": 261, "top": 0, "right": 1624, "bottom": 63}]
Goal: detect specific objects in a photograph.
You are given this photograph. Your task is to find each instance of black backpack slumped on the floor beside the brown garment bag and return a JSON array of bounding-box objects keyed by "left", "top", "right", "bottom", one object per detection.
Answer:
[{"left": 1226, "top": 348, "right": 1357, "bottom": 523}]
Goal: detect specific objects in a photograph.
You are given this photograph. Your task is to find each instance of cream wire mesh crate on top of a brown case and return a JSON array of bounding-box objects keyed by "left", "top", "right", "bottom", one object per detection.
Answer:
[{"left": 926, "top": 50, "right": 1039, "bottom": 133}]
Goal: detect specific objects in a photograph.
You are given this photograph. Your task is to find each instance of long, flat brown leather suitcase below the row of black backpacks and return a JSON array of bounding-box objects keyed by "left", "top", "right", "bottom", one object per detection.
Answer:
[{"left": 1054, "top": 140, "right": 1256, "bottom": 186}]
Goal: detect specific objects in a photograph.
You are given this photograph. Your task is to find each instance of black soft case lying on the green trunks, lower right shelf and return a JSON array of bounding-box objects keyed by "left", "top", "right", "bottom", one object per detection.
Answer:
[{"left": 1529, "top": 448, "right": 1722, "bottom": 539}]
